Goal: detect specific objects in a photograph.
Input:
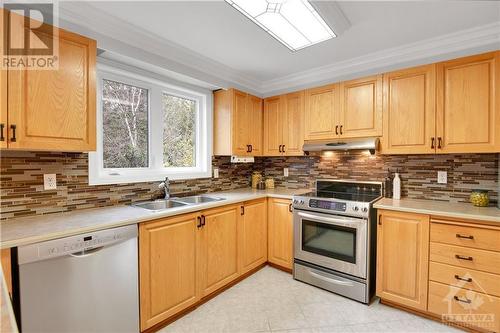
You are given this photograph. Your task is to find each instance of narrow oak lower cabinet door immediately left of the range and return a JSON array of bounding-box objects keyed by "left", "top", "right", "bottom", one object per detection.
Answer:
[{"left": 267, "top": 198, "right": 293, "bottom": 269}]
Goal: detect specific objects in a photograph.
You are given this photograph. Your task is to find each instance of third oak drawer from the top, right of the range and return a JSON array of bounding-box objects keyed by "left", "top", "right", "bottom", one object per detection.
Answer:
[{"left": 429, "top": 262, "right": 500, "bottom": 297}]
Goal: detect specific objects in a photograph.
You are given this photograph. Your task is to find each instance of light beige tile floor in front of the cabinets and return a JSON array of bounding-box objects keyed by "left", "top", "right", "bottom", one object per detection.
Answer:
[{"left": 160, "top": 266, "right": 462, "bottom": 333}]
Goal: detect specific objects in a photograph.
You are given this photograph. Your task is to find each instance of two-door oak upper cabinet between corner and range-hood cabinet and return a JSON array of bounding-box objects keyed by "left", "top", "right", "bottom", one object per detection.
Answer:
[{"left": 263, "top": 91, "right": 304, "bottom": 156}]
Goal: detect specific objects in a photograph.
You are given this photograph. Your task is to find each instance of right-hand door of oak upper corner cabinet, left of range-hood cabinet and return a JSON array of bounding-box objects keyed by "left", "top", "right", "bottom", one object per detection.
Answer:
[{"left": 281, "top": 91, "right": 304, "bottom": 156}]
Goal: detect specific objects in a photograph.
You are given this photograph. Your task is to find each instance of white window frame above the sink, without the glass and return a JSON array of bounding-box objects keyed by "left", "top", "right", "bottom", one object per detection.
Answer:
[{"left": 89, "top": 64, "right": 212, "bottom": 185}]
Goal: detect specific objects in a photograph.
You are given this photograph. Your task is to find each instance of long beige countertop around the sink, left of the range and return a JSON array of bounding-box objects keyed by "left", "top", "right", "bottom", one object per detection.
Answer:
[{"left": 0, "top": 188, "right": 308, "bottom": 249}]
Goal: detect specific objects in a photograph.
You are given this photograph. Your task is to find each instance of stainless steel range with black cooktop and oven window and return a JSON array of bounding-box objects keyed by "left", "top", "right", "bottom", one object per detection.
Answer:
[{"left": 293, "top": 180, "right": 382, "bottom": 303}]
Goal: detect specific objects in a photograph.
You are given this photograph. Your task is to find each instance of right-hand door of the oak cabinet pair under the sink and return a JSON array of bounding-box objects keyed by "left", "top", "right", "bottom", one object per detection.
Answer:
[{"left": 198, "top": 206, "right": 240, "bottom": 297}]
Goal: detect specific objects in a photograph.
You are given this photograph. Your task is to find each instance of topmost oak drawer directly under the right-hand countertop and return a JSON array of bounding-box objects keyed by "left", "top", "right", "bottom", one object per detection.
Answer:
[{"left": 431, "top": 222, "right": 500, "bottom": 251}]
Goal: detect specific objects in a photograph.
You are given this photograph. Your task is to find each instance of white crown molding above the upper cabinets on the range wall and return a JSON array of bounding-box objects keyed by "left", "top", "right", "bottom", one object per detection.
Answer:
[{"left": 260, "top": 22, "right": 500, "bottom": 96}]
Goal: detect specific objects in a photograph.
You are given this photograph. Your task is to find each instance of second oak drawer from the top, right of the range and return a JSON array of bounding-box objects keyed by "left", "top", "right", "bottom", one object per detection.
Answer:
[{"left": 429, "top": 242, "right": 500, "bottom": 274}]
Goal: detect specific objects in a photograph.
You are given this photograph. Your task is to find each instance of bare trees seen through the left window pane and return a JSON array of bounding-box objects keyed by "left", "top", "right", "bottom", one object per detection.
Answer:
[{"left": 102, "top": 80, "right": 149, "bottom": 168}]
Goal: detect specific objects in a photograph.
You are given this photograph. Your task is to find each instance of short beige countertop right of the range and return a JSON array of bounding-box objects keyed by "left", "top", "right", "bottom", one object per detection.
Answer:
[{"left": 373, "top": 198, "right": 500, "bottom": 226}]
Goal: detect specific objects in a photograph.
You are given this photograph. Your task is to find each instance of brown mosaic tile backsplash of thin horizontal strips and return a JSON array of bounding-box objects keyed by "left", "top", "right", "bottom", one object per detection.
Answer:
[{"left": 0, "top": 151, "right": 499, "bottom": 219}]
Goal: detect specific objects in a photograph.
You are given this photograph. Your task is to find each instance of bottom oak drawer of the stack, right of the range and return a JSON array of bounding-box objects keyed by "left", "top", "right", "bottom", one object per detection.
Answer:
[{"left": 428, "top": 281, "right": 500, "bottom": 332}]
